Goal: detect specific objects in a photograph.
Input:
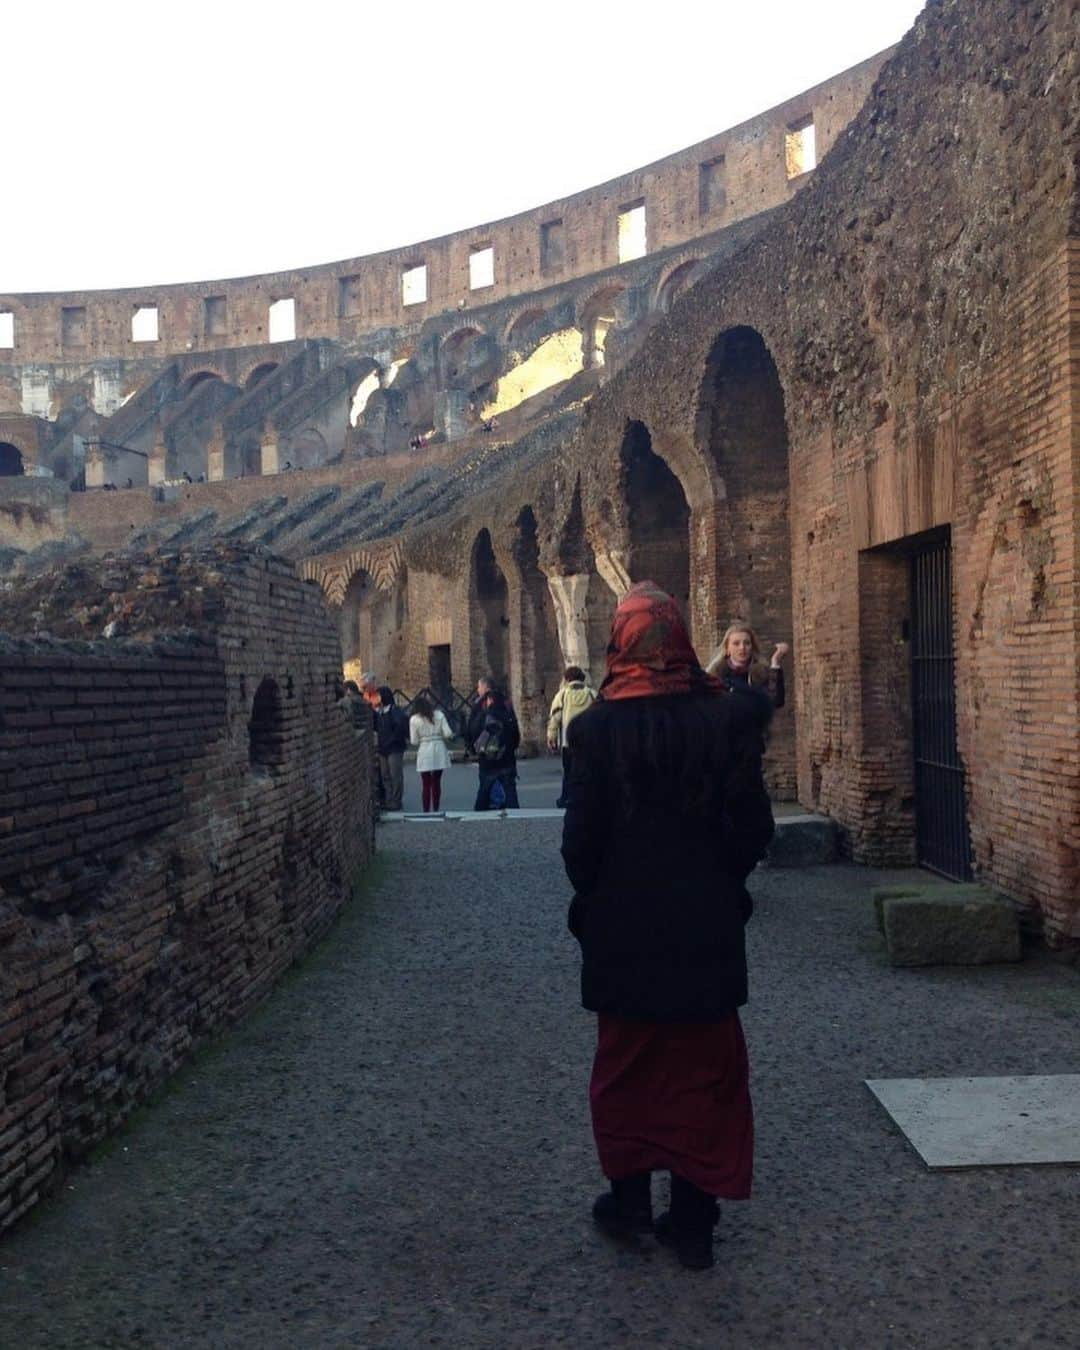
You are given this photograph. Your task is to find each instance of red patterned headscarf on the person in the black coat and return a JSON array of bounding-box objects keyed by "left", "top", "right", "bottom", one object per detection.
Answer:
[{"left": 599, "top": 582, "right": 726, "bottom": 699}]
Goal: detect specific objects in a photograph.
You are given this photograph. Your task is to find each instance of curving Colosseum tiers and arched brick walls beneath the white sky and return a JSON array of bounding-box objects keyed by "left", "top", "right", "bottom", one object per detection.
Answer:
[{"left": 0, "top": 0, "right": 1080, "bottom": 1225}]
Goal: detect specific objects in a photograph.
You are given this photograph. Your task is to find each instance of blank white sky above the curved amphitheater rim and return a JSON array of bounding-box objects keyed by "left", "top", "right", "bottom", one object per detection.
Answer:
[{"left": 0, "top": 0, "right": 922, "bottom": 292}]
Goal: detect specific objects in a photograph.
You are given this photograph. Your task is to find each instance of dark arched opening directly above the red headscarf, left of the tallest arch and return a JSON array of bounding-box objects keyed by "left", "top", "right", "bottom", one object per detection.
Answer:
[{"left": 620, "top": 421, "right": 690, "bottom": 618}]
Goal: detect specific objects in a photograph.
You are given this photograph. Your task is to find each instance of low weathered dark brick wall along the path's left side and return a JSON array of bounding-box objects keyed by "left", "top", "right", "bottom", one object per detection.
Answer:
[{"left": 0, "top": 548, "right": 373, "bottom": 1227}]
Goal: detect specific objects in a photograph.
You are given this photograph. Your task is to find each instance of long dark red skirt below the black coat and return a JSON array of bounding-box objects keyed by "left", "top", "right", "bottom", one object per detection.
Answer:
[{"left": 589, "top": 1013, "right": 753, "bottom": 1200}]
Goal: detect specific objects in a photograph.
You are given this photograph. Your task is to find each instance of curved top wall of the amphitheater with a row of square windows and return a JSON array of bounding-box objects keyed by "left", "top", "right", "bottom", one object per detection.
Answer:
[{"left": 0, "top": 53, "right": 888, "bottom": 369}]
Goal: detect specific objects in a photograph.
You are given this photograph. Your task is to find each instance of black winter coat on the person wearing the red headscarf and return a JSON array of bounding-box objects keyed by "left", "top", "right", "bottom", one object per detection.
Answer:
[{"left": 563, "top": 694, "right": 774, "bottom": 1022}]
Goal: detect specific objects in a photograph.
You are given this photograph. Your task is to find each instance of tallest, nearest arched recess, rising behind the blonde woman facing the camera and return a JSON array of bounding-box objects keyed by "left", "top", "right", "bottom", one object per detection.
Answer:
[{"left": 698, "top": 328, "right": 795, "bottom": 797}]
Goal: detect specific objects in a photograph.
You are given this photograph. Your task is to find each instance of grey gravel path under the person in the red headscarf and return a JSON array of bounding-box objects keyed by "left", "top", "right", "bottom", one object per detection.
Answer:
[{"left": 0, "top": 821, "right": 1080, "bottom": 1350}]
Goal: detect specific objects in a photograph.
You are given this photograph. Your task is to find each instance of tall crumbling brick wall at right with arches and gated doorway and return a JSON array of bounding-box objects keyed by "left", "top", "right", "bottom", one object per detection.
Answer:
[{"left": 315, "top": 0, "right": 1080, "bottom": 942}]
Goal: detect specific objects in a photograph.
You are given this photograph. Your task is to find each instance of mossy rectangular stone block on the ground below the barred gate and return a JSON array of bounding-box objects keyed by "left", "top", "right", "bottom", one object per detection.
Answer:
[{"left": 872, "top": 883, "right": 1021, "bottom": 965}]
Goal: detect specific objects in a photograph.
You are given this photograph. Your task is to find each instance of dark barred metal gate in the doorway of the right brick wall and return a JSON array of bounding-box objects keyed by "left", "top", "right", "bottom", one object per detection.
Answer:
[{"left": 911, "top": 539, "right": 971, "bottom": 882}]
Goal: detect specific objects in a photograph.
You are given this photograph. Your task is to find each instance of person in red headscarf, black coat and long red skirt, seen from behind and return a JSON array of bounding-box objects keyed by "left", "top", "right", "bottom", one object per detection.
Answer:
[{"left": 563, "top": 582, "right": 774, "bottom": 1269}]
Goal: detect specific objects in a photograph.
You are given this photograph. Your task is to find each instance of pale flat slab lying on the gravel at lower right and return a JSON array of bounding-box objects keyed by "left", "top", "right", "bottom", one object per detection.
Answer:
[{"left": 867, "top": 1073, "right": 1080, "bottom": 1168}]
